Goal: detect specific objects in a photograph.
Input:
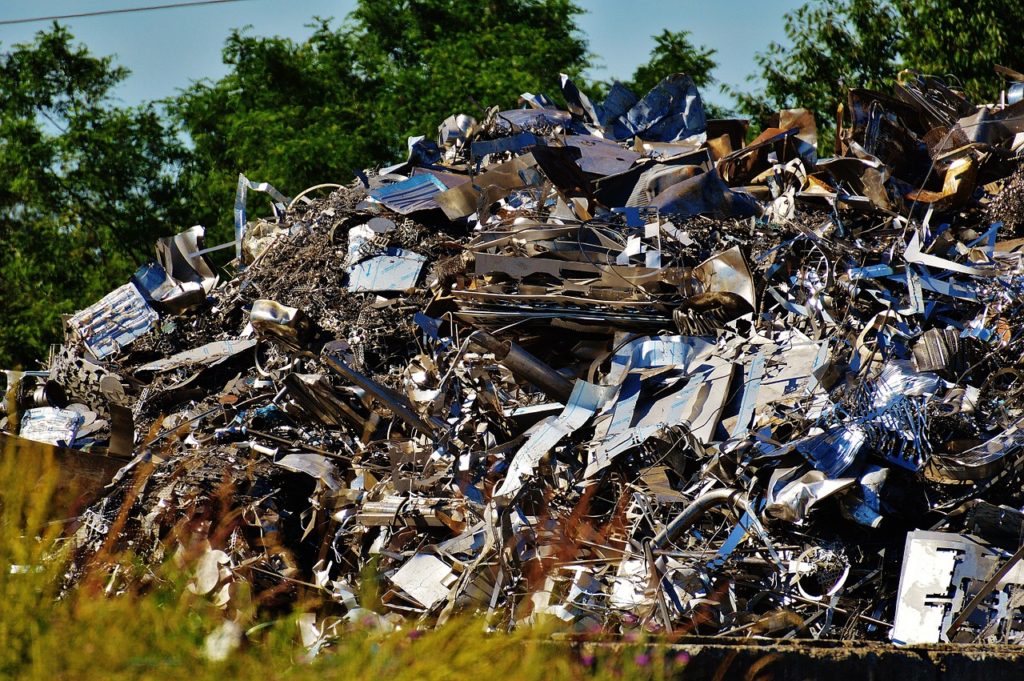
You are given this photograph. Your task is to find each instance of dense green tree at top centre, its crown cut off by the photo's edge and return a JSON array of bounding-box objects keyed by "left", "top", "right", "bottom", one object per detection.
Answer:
[{"left": 349, "top": 0, "right": 588, "bottom": 142}]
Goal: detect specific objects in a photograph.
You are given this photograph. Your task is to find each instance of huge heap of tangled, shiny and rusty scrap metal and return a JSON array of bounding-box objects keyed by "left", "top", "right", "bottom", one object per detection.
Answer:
[{"left": 4, "top": 73, "right": 1024, "bottom": 644}]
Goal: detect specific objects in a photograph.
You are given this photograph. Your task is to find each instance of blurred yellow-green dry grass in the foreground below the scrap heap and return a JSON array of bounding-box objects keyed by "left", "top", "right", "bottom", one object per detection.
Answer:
[{"left": 0, "top": 438, "right": 685, "bottom": 681}]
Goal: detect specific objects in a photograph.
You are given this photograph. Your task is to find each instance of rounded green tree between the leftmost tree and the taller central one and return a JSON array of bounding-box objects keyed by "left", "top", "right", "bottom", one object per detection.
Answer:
[{"left": 171, "top": 22, "right": 382, "bottom": 241}]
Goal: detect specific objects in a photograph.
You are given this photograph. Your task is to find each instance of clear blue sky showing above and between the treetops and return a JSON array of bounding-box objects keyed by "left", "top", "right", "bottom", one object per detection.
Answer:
[{"left": 0, "top": 0, "right": 802, "bottom": 109}]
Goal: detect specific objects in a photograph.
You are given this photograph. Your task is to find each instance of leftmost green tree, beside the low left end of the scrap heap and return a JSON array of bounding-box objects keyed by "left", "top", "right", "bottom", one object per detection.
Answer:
[{"left": 0, "top": 25, "right": 182, "bottom": 368}]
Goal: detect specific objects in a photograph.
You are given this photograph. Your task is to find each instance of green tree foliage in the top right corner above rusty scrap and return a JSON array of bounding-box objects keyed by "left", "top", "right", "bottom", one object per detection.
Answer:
[{"left": 733, "top": 0, "right": 1024, "bottom": 139}]
